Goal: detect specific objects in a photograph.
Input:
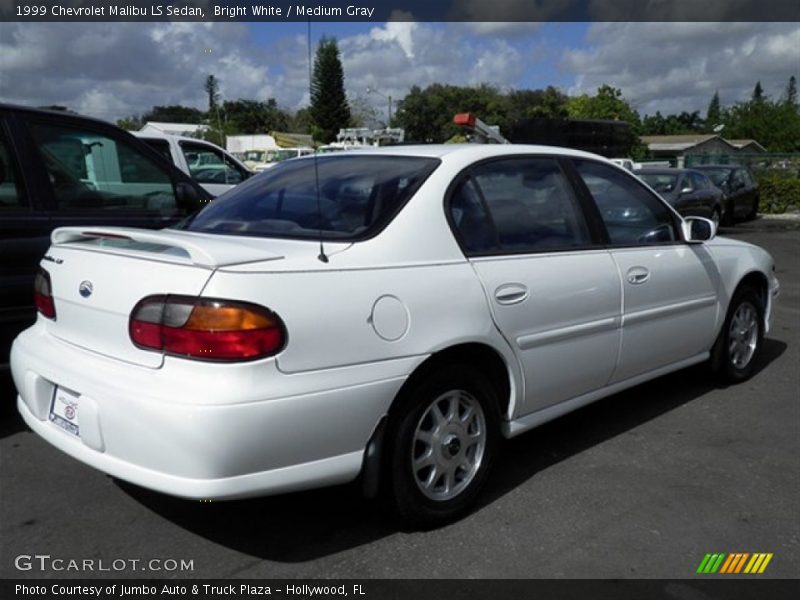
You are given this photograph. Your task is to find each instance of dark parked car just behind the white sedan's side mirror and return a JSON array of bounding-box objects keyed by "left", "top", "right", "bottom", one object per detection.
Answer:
[{"left": 634, "top": 169, "right": 724, "bottom": 227}]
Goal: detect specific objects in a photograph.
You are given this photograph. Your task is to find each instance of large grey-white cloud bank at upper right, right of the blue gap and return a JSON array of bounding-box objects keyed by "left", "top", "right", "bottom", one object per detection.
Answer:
[{"left": 561, "top": 23, "right": 800, "bottom": 114}]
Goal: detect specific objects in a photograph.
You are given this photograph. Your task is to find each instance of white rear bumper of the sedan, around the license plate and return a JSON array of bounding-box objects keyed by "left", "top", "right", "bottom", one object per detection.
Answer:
[{"left": 11, "top": 326, "right": 417, "bottom": 499}]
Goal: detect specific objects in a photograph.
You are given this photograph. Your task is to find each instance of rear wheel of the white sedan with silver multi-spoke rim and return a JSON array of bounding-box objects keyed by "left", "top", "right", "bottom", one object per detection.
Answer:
[{"left": 385, "top": 365, "right": 499, "bottom": 528}]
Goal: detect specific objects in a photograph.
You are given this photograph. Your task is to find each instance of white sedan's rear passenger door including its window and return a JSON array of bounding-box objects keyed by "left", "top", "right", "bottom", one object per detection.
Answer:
[{"left": 449, "top": 156, "right": 621, "bottom": 416}]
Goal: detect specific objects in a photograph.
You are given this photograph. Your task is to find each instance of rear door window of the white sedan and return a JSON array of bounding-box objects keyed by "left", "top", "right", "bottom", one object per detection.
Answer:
[{"left": 450, "top": 158, "right": 591, "bottom": 254}]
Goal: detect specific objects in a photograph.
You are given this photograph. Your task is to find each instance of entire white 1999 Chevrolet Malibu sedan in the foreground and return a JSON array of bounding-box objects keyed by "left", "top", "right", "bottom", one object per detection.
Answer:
[{"left": 11, "top": 145, "right": 779, "bottom": 525}]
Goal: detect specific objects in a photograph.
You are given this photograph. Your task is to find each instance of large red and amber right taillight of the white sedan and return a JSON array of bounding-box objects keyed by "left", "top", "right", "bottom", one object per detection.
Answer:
[{"left": 133, "top": 296, "right": 286, "bottom": 361}]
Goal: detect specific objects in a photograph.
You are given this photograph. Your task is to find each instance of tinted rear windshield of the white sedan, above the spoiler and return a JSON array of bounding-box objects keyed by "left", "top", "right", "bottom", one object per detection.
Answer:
[{"left": 180, "top": 154, "right": 439, "bottom": 240}]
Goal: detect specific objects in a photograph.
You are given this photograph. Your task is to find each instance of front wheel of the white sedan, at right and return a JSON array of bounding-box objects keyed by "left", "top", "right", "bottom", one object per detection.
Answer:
[{"left": 711, "top": 287, "right": 764, "bottom": 383}]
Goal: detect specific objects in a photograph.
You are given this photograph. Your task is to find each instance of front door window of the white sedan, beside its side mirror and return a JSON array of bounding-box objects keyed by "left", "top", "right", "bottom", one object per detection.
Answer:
[{"left": 574, "top": 160, "right": 680, "bottom": 246}]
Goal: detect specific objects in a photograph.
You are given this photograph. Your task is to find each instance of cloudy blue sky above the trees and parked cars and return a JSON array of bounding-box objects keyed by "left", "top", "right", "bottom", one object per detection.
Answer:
[{"left": 0, "top": 21, "right": 800, "bottom": 121}]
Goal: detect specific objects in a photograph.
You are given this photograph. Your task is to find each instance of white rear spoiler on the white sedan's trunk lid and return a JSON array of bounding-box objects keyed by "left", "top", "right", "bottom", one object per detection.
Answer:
[{"left": 50, "top": 227, "right": 283, "bottom": 268}]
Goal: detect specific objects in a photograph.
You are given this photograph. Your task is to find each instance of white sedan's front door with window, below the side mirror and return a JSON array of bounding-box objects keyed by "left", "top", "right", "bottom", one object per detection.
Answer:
[{"left": 573, "top": 159, "right": 721, "bottom": 383}]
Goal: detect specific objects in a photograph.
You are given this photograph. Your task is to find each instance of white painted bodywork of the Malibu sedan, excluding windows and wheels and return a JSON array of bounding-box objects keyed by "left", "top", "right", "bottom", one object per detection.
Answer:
[{"left": 11, "top": 145, "right": 778, "bottom": 524}]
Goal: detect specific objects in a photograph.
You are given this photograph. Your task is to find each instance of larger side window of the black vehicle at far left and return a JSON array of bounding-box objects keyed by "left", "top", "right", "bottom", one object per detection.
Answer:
[{"left": 31, "top": 123, "right": 177, "bottom": 215}]
